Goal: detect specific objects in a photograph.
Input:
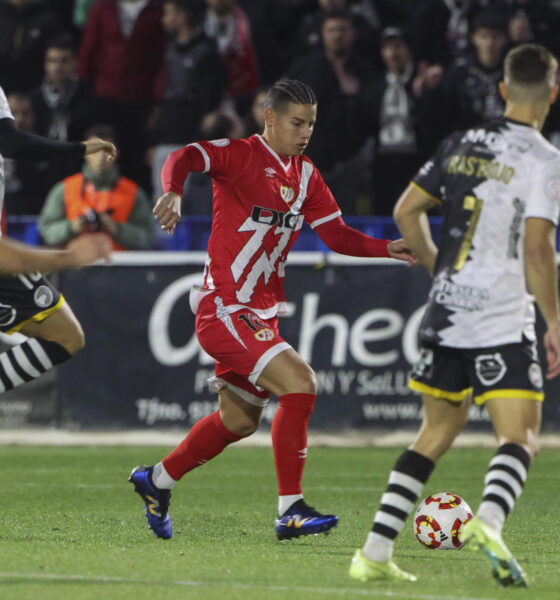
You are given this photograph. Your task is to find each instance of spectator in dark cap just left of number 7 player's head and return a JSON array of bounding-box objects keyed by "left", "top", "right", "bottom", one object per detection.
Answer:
[{"left": 430, "top": 9, "right": 508, "bottom": 138}]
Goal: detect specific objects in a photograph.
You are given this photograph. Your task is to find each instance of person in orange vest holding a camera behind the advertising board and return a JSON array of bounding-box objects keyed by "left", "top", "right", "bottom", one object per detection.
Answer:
[{"left": 39, "top": 125, "right": 154, "bottom": 250}]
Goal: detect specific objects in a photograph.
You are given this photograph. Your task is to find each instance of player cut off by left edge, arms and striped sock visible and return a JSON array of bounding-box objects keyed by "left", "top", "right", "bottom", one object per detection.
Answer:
[{"left": 0, "top": 87, "right": 116, "bottom": 393}]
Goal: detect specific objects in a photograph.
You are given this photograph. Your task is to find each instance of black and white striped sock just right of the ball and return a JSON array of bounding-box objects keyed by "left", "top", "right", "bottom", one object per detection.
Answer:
[{"left": 477, "top": 443, "right": 531, "bottom": 533}]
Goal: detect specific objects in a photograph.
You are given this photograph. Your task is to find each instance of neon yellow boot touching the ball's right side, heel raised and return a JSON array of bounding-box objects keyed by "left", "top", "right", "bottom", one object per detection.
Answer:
[{"left": 463, "top": 517, "right": 527, "bottom": 587}]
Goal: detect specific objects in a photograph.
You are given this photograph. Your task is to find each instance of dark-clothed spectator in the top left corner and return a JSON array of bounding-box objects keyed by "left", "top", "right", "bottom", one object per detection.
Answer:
[{"left": 0, "top": 0, "right": 62, "bottom": 94}]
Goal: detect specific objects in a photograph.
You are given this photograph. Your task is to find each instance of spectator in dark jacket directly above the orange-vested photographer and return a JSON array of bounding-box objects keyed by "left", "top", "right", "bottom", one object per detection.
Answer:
[{"left": 30, "top": 34, "right": 100, "bottom": 195}]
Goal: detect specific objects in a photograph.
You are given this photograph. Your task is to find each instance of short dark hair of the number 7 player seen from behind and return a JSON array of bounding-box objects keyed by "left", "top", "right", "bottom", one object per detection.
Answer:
[{"left": 504, "top": 44, "right": 558, "bottom": 101}]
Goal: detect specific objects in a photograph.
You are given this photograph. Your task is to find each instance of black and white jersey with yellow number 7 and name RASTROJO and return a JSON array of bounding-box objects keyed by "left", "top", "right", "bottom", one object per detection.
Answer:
[{"left": 412, "top": 117, "right": 560, "bottom": 348}]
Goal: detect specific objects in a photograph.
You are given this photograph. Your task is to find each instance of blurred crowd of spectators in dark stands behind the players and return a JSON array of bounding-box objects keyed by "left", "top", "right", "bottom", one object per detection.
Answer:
[{"left": 0, "top": 0, "right": 560, "bottom": 236}]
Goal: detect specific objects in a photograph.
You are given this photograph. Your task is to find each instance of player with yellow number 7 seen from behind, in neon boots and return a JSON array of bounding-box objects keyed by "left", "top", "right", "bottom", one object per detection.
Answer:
[{"left": 350, "top": 44, "right": 560, "bottom": 586}]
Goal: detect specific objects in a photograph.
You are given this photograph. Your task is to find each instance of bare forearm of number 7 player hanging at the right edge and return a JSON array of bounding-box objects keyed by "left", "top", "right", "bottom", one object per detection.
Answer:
[{"left": 524, "top": 217, "right": 560, "bottom": 379}]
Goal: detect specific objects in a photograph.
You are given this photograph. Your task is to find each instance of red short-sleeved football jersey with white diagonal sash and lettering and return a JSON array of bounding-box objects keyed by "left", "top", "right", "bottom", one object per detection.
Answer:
[{"left": 190, "top": 135, "right": 340, "bottom": 319}]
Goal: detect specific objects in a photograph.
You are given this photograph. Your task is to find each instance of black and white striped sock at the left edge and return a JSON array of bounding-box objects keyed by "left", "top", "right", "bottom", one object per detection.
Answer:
[{"left": 0, "top": 338, "right": 71, "bottom": 394}]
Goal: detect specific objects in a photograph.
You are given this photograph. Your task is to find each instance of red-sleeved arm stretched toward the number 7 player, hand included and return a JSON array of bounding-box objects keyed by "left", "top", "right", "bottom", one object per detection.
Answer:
[{"left": 314, "top": 217, "right": 416, "bottom": 265}]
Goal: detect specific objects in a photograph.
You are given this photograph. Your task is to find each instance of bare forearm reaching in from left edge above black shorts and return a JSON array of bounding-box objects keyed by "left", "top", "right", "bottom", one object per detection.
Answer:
[{"left": 0, "top": 233, "right": 111, "bottom": 275}]
